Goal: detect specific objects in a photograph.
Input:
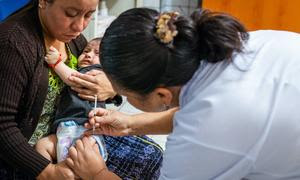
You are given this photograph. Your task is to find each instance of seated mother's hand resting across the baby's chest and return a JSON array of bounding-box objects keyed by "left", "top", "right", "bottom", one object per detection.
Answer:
[{"left": 69, "top": 70, "right": 116, "bottom": 101}]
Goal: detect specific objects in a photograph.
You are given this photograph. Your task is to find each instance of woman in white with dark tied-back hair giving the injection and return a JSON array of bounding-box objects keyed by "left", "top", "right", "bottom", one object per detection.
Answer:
[{"left": 67, "top": 8, "right": 300, "bottom": 180}]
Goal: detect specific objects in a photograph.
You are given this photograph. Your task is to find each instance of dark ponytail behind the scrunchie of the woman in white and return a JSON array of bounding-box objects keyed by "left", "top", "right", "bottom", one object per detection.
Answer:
[{"left": 191, "top": 10, "right": 249, "bottom": 62}]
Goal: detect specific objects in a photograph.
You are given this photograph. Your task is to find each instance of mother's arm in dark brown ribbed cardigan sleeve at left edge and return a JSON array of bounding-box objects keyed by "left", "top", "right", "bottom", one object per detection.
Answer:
[{"left": 0, "top": 38, "right": 50, "bottom": 177}]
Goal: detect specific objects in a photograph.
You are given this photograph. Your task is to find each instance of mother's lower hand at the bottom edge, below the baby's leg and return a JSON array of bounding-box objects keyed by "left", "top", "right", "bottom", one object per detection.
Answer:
[{"left": 36, "top": 161, "right": 78, "bottom": 180}]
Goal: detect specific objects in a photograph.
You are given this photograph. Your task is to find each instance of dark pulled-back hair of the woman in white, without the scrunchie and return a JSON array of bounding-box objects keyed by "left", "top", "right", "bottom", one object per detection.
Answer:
[{"left": 100, "top": 8, "right": 248, "bottom": 95}]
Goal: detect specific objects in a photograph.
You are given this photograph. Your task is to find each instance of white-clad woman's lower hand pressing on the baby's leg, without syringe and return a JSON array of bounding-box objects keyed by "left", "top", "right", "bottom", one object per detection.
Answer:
[{"left": 66, "top": 137, "right": 108, "bottom": 179}]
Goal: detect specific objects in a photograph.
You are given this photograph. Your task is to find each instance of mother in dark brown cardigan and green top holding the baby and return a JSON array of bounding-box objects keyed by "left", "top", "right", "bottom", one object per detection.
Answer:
[{"left": 0, "top": 0, "right": 161, "bottom": 179}]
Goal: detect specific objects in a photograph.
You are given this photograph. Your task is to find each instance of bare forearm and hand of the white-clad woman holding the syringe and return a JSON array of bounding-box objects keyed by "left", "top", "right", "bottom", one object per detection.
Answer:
[{"left": 85, "top": 108, "right": 178, "bottom": 136}]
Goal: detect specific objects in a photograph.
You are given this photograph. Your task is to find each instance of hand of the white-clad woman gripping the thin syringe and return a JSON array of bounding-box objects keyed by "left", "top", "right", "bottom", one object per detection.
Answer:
[{"left": 85, "top": 108, "right": 131, "bottom": 136}]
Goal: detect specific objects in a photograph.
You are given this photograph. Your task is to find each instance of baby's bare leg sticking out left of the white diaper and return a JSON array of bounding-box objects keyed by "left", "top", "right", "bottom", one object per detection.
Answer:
[{"left": 35, "top": 134, "right": 57, "bottom": 162}]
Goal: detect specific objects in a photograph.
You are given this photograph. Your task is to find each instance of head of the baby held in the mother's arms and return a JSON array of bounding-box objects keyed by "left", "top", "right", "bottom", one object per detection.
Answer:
[{"left": 78, "top": 38, "right": 101, "bottom": 67}]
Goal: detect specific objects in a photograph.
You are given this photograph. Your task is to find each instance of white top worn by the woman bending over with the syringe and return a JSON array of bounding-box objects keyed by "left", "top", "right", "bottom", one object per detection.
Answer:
[{"left": 160, "top": 31, "right": 300, "bottom": 180}]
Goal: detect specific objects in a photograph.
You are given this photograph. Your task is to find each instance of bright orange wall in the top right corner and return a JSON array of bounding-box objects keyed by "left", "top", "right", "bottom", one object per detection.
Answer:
[{"left": 202, "top": 0, "right": 300, "bottom": 32}]
